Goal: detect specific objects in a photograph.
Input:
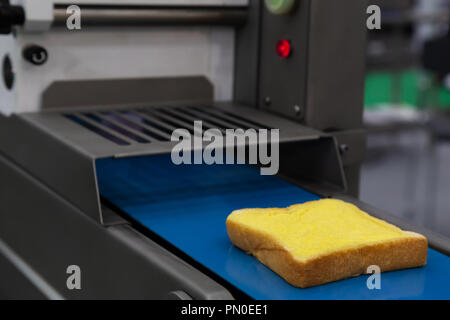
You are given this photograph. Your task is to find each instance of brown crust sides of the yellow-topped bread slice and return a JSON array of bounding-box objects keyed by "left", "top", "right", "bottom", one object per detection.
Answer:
[{"left": 227, "top": 220, "right": 428, "bottom": 288}]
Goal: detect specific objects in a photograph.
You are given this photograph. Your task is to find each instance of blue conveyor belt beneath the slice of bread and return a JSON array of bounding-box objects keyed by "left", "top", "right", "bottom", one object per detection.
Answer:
[{"left": 97, "top": 155, "right": 450, "bottom": 300}]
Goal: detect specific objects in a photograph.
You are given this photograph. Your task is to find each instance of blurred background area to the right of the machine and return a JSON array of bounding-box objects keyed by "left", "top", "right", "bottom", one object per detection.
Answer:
[{"left": 361, "top": 0, "right": 450, "bottom": 237}]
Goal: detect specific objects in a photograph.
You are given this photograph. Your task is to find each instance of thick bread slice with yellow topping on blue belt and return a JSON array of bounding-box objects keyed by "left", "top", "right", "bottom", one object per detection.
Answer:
[{"left": 227, "top": 199, "right": 428, "bottom": 288}]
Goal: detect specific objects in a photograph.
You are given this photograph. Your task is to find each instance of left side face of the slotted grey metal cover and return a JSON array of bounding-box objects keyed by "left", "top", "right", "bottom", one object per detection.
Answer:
[{"left": 0, "top": 116, "right": 102, "bottom": 223}]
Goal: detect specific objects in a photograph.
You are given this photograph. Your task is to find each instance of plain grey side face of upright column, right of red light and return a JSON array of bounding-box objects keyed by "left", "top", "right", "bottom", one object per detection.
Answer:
[{"left": 305, "top": 0, "right": 367, "bottom": 131}]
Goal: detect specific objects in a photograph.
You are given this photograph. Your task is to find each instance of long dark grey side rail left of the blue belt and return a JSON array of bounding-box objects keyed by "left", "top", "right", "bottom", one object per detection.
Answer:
[{"left": 0, "top": 157, "right": 232, "bottom": 299}]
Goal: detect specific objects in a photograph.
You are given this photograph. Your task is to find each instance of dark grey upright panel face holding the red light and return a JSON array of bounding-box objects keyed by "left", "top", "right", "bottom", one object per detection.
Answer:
[{"left": 258, "top": 1, "right": 310, "bottom": 120}]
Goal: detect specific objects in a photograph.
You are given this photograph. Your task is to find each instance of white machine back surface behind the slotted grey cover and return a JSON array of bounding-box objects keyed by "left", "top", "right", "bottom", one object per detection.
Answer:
[{"left": 0, "top": 0, "right": 244, "bottom": 115}]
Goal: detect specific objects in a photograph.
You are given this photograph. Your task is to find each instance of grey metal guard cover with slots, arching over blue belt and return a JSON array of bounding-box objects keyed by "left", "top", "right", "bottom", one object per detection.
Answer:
[{"left": 0, "top": 103, "right": 346, "bottom": 223}]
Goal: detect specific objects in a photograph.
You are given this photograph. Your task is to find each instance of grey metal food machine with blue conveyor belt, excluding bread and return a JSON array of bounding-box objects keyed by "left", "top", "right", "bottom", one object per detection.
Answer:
[{"left": 0, "top": 0, "right": 450, "bottom": 299}]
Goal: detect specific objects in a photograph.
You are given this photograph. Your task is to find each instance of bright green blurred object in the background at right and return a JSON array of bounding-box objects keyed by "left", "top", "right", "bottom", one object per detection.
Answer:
[{"left": 365, "top": 69, "right": 450, "bottom": 110}]
